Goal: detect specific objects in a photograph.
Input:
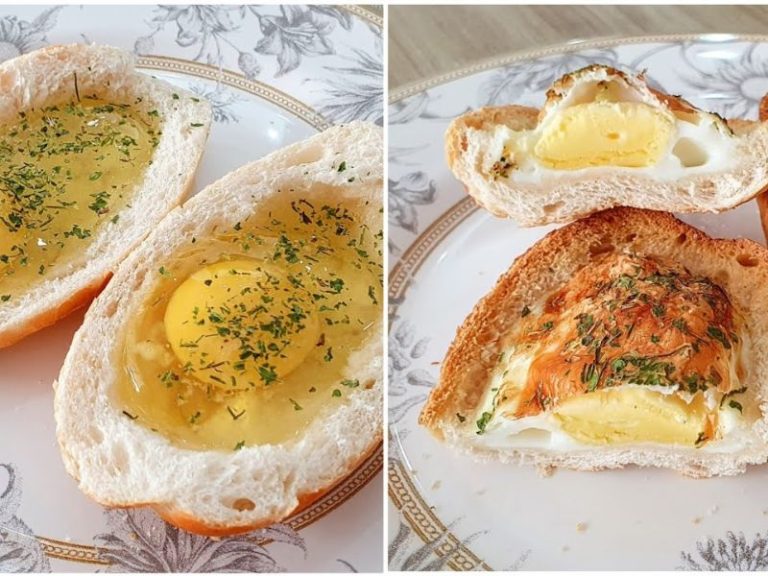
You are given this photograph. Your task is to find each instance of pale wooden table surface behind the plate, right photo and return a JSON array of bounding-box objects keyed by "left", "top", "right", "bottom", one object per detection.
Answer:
[{"left": 388, "top": 6, "right": 768, "bottom": 91}]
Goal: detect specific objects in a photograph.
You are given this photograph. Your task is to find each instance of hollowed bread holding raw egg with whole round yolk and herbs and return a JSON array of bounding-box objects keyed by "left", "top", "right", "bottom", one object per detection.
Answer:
[{"left": 55, "top": 123, "right": 383, "bottom": 535}]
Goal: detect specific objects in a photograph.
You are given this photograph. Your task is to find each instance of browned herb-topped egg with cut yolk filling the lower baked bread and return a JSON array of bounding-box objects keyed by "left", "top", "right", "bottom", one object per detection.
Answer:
[{"left": 484, "top": 251, "right": 746, "bottom": 446}]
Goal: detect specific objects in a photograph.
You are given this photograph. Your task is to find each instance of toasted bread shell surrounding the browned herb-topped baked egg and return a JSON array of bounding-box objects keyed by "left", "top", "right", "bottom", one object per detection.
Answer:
[{"left": 419, "top": 208, "right": 768, "bottom": 476}]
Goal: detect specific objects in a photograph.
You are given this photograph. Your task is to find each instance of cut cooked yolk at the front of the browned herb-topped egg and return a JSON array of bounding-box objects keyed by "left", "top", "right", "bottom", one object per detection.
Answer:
[{"left": 554, "top": 388, "right": 716, "bottom": 446}]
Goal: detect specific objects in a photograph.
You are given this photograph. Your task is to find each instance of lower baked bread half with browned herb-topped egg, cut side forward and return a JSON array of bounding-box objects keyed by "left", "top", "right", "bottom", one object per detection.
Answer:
[{"left": 420, "top": 208, "right": 768, "bottom": 476}]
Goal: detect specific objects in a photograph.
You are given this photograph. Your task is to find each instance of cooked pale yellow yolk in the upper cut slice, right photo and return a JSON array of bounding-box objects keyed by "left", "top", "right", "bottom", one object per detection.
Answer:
[{"left": 534, "top": 101, "right": 674, "bottom": 170}]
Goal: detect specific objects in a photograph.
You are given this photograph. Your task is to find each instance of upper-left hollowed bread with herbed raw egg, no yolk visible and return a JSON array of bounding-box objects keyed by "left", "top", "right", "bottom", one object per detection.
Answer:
[{"left": 0, "top": 45, "right": 211, "bottom": 347}]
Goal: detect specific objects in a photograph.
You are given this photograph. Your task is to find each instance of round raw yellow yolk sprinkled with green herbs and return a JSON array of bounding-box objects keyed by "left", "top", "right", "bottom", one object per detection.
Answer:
[{"left": 164, "top": 259, "right": 319, "bottom": 391}]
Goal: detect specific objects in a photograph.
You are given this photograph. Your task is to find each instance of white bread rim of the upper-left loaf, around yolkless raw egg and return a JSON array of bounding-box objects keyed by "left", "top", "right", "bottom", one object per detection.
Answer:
[{"left": 0, "top": 44, "right": 212, "bottom": 348}]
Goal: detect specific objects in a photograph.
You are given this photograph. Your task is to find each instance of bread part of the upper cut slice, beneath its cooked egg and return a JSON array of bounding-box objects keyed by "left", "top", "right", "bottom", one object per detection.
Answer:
[{"left": 445, "top": 66, "right": 768, "bottom": 226}]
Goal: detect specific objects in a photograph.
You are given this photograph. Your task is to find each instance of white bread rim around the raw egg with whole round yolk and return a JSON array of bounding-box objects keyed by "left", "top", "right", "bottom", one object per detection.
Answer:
[{"left": 54, "top": 123, "right": 383, "bottom": 535}]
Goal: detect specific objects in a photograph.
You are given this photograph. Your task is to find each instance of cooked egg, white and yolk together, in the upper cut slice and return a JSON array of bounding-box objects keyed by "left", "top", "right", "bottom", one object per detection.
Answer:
[{"left": 483, "top": 70, "right": 736, "bottom": 183}]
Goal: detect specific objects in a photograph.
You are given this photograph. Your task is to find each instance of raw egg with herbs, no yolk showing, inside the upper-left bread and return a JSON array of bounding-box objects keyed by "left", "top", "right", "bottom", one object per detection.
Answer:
[{"left": 0, "top": 98, "right": 160, "bottom": 301}]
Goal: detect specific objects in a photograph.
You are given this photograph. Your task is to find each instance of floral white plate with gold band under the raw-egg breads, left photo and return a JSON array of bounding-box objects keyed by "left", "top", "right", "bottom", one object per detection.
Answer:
[{"left": 0, "top": 6, "right": 383, "bottom": 572}]
